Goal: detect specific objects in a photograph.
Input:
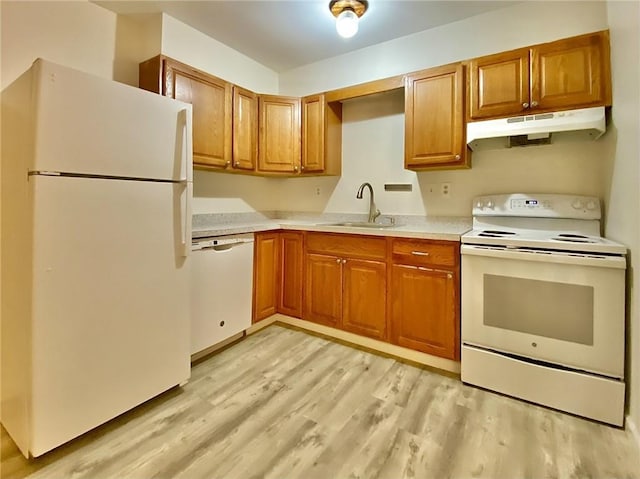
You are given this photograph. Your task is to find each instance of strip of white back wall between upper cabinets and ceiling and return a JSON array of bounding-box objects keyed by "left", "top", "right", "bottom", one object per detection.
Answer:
[{"left": 280, "top": 1, "right": 607, "bottom": 96}]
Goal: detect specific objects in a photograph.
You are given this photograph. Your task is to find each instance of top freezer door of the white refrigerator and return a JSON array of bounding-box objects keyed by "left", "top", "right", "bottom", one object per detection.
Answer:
[{"left": 29, "top": 60, "right": 192, "bottom": 180}]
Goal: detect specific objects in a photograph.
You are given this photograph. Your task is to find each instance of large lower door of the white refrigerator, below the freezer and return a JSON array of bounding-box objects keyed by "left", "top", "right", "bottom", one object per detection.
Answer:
[{"left": 29, "top": 176, "right": 190, "bottom": 456}]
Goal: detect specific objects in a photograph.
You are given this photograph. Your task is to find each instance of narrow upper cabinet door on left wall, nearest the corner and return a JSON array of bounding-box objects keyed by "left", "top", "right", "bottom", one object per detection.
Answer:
[{"left": 233, "top": 86, "right": 258, "bottom": 170}]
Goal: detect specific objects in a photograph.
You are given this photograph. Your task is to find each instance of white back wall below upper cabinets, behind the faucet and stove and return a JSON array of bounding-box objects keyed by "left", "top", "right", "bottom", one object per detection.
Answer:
[{"left": 279, "top": 93, "right": 610, "bottom": 216}]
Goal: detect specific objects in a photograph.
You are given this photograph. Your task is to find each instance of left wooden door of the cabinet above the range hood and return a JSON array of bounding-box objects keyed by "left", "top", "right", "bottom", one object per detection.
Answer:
[{"left": 469, "top": 48, "right": 529, "bottom": 120}]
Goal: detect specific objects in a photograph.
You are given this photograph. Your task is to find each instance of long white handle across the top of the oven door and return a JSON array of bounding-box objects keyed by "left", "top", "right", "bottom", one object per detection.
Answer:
[{"left": 460, "top": 244, "right": 627, "bottom": 269}]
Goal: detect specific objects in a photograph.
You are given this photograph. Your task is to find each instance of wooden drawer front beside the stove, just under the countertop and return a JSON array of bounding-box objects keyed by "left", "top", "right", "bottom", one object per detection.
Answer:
[{"left": 392, "top": 239, "right": 460, "bottom": 267}]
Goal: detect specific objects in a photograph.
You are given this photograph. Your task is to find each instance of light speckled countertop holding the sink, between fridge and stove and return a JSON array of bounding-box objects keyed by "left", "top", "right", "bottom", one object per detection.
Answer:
[{"left": 192, "top": 212, "right": 471, "bottom": 241}]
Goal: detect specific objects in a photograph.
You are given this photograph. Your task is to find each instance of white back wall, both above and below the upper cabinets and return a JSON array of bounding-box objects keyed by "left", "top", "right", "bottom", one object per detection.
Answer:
[{"left": 272, "top": 2, "right": 611, "bottom": 216}]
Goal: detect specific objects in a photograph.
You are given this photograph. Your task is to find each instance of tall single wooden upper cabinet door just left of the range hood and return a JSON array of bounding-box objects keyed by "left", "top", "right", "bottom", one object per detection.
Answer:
[{"left": 405, "top": 64, "right": 468, "bottom": 170}]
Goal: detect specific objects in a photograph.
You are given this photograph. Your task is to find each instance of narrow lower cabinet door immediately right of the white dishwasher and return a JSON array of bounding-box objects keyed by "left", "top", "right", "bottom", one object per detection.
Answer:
[{"left": 253, "top": 233, "right": 279, "bottom": 323}]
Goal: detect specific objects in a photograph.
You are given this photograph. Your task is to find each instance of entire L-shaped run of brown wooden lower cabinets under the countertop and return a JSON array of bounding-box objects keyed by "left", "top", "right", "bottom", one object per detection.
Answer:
[{"left": 254, "top": 231, "right": 460, "bottom": 361}]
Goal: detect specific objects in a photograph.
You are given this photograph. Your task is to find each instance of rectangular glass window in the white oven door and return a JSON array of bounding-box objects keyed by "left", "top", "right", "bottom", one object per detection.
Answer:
[{"left": 483, "top": 274, "right": 594, "bottom": 345}]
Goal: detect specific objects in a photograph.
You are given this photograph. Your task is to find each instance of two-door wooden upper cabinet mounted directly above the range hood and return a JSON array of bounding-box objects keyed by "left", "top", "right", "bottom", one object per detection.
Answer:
[{"left": 468, "top": 31, "right": 611, "bottom": 120}]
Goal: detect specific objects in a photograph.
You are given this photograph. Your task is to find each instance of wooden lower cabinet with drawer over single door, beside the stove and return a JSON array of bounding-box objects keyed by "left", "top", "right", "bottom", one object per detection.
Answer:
[{"left": 389, "top": 239, "right": 460, "bottom": 361}]
